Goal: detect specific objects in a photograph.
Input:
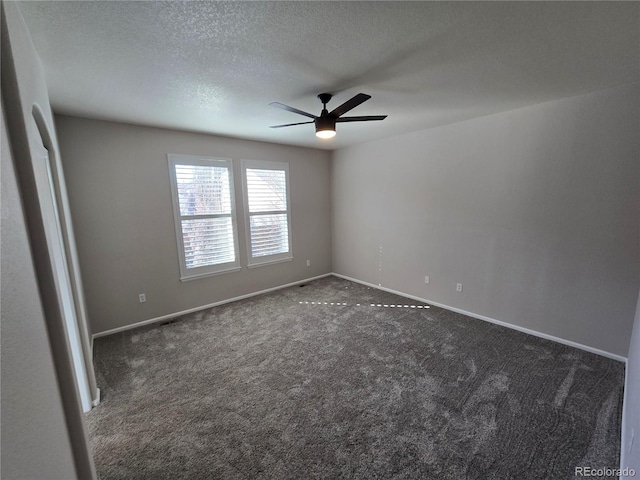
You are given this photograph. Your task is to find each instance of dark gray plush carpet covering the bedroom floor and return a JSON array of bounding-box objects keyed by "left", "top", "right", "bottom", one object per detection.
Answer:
[{"left": 87, "top": 277, "right": 624, "bottom": 479}]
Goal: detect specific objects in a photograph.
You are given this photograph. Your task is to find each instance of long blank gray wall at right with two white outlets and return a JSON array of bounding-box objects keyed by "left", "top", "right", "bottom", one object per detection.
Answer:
[{"left": 332, "top": 85, "right": 640, "bottom": 356}]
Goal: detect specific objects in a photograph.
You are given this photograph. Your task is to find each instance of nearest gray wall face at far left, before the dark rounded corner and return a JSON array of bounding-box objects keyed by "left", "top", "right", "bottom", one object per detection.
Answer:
[{"left": 0, "top": 93, "right": 76, "bottom": 479}]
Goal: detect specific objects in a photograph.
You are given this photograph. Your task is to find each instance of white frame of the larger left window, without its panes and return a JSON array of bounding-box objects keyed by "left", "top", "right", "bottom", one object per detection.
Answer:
[{"left": 167, "top": 153, "right": 241, "bottom": 281}]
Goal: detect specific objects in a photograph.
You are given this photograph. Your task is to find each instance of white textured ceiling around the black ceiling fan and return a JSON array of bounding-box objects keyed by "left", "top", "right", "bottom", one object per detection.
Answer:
[{"left": 20, "top": 1, "right": 640, "bottom": 149}]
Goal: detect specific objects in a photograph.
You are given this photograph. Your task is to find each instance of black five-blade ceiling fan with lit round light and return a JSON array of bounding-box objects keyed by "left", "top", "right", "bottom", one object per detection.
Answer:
[{"left": 269, "top": 93, "right": 387, "bottom": 138}]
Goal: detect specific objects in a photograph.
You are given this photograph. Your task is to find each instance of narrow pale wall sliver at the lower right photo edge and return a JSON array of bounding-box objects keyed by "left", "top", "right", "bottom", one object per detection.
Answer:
[{"left": 620, "top": 292, "right": 640, "bottom": 474}]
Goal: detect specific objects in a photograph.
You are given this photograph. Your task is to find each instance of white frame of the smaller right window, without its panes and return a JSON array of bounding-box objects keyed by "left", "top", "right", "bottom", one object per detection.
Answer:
[{"left": 242, "top": 160, "right": 293, "bottom": 268}]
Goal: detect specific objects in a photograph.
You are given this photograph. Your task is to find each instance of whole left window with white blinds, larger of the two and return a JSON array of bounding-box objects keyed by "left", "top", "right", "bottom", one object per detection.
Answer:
[{"left": 168, "top": 154, "right": 240, "bottom": 280}]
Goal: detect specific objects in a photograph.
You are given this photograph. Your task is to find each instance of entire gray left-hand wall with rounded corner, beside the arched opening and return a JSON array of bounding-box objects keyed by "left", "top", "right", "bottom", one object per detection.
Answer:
[{"left": 0, "top": 2, "right": 94, "bottom": 480}]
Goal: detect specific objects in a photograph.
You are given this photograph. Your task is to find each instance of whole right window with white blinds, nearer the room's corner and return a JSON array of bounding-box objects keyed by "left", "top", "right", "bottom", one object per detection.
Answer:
[{"left": 242, "top": 160, "right": 293, "bottom": 267}]
